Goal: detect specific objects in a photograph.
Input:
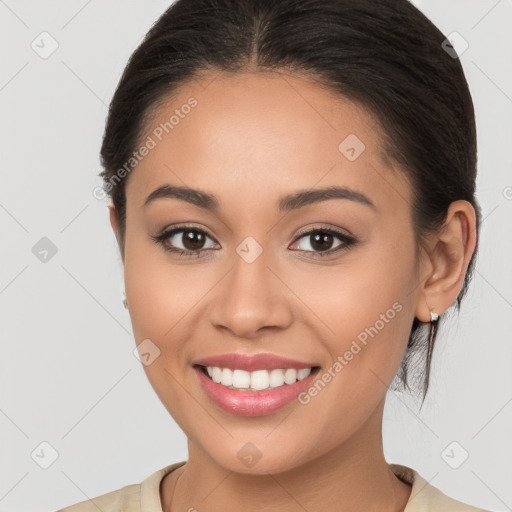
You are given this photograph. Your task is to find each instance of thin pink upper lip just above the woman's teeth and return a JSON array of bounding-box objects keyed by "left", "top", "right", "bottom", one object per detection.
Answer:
[{"left": 193, "top": 353, "right": 318, "bottom": 372}]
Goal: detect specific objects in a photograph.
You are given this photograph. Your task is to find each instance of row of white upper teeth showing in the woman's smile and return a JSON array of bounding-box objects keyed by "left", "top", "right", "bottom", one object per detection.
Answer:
[{"left": 206, "top": 366, "right": 311, "bottom": 391}]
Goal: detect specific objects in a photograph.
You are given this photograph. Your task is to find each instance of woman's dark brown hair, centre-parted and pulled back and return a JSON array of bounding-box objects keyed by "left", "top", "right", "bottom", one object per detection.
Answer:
[{"left": 100, "top": 0, "right": 481, "bottom": 403}]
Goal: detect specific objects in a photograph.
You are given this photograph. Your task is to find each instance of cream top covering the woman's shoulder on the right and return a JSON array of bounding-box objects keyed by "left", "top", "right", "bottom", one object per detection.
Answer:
[{"left": 390, "top": 464, "right": 490, "bottom": 512}]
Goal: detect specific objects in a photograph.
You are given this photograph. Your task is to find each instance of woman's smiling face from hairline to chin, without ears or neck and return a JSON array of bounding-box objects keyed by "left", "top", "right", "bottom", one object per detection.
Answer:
[{"left": 117, "top": 73, "right": 419, "bottom": 474}]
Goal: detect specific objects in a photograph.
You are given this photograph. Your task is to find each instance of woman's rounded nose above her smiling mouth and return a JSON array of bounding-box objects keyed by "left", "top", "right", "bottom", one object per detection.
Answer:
[{"left": 209, "top": 245, "right": 293, "bottom": 339}]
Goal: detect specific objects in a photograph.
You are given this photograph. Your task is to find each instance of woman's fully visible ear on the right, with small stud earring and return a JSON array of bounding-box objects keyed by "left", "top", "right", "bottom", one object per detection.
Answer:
[{"left": 415, "top": 199, "right": 477, "bottom": 323}]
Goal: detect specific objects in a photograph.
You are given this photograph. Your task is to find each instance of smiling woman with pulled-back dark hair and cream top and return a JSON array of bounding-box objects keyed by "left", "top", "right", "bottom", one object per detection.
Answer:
[{"left": 58, "top": 0, "right": 490, "bottom": 512}]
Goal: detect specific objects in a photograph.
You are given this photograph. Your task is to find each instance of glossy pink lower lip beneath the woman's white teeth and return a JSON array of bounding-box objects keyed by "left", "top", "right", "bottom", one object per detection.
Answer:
[{"left": 194, "top": 367, "right": 319, "bottom": 416}]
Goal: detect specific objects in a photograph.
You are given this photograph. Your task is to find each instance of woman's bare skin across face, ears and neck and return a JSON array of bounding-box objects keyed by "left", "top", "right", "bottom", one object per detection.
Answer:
[{"left": 110, "top": 71, "right": 476, "bottom": 512}]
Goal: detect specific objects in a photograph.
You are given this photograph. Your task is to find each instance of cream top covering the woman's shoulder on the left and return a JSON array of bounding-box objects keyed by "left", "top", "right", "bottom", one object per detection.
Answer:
[{"left": 57, "top": 461, "right": 185, "bottom": 512}]
